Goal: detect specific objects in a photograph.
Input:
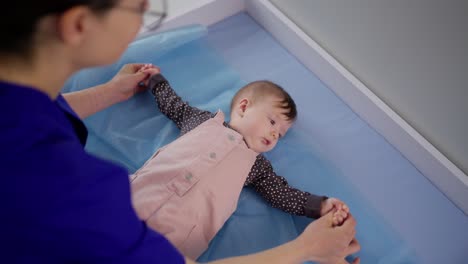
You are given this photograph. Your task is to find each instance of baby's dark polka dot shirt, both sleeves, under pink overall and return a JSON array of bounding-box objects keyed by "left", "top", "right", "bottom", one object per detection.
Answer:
[{"left": 149, "top": 74, "right": 327, "bottom": 218}]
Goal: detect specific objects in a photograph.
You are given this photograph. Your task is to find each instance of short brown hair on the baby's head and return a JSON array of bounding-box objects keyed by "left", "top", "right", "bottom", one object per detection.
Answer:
[{"left": 231, "top": 80, "right": 297, "bottom": 121}]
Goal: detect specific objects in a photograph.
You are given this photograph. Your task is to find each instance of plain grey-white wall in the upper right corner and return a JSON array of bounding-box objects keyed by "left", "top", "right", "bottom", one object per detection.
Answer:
[{"left": 271, "top": 0, "right": 468, "bottom": 174}]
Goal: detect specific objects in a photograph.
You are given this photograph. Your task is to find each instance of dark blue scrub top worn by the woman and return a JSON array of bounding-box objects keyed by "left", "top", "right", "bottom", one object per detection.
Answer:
[{"left": 0, "top": 82, "right": 185, "bottom": 263}]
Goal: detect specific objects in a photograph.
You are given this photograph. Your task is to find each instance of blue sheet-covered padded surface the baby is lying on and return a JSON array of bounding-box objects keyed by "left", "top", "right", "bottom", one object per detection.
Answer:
[{"left": 64, "top": 13, "right": 468, "bottom": 264}]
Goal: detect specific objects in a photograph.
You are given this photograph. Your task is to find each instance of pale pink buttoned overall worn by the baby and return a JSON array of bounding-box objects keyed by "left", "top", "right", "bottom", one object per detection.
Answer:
[{"left": 131, "top": 111, "right": 258, "bottom": 259}]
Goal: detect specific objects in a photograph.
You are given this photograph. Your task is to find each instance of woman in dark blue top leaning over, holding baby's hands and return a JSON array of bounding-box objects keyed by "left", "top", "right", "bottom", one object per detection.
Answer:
[{"left": 0, "top": 0, "right": 359, "bottom": 263}]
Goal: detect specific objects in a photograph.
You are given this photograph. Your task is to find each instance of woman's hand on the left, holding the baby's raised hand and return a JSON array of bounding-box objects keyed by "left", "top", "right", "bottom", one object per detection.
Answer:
[{"left": 106, "top": 63, "right": 160, "bottom": 102}]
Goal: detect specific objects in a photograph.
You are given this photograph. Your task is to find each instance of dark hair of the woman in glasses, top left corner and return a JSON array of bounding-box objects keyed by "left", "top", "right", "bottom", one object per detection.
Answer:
[{"left": 0, "top": 0, "right": 119, "bottom": 56}]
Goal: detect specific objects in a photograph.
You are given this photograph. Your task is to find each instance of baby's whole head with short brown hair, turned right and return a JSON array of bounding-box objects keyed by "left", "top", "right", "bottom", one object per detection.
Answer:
[{"left": 229, "top": 81, "right": 297, "bottom": 153}]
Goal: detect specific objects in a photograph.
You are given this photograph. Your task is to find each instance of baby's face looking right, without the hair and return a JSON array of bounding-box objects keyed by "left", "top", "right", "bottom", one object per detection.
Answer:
[{"left": 235, "top": 97, "right": 292, "bottom": 153}]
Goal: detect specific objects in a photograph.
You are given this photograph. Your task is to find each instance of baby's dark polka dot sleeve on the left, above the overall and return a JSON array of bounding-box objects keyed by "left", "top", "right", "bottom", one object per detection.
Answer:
[{"left": 149, "top": 74, "right": 213, "bottom": 135}]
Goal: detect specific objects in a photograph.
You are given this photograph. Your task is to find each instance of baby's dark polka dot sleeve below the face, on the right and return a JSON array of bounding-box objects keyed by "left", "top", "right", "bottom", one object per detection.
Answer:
[{"left": 245, "top": 155, "right": 327, "bottom": 218}]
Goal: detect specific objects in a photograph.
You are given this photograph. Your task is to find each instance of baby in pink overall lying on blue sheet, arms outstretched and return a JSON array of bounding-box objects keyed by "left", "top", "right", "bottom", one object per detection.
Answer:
[{"left": 131, "top": 66, "right": 349, "bottom": 259}]
